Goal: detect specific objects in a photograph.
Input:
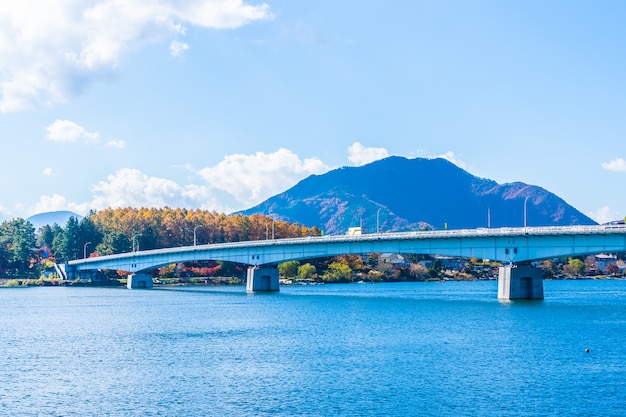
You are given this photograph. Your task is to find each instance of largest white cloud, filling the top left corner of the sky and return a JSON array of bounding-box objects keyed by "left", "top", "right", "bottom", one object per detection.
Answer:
[{"left": 0, "top": 0, "right": 272, "bottom": 112}]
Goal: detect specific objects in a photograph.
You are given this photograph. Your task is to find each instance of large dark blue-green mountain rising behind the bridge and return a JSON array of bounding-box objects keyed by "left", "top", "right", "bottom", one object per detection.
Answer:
[{"left": 240, "top": 156, "right": 597, "bottom": 234}]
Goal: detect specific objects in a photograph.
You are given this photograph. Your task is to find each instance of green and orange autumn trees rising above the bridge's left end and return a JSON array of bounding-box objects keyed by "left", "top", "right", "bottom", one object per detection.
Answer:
[{"left": 0, "top": 208, "right": 322, "bottom": 277}]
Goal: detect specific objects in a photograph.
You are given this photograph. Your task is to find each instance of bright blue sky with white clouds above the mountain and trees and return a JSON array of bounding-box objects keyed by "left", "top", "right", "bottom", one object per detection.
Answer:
[{"left": 0, "top": 0, "right": 626, "bottom": 223}]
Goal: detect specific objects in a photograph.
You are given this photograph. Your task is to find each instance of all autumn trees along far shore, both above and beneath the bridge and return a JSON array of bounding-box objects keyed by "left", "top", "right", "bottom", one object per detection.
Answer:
[{"left": 0, "top": 208, "right": 620, "bottom": 285}]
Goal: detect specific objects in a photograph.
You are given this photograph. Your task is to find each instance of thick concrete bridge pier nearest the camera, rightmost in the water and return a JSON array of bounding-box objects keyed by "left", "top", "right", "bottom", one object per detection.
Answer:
[{"left": 498, "top": 266, "right": 543, "bottom": 300}]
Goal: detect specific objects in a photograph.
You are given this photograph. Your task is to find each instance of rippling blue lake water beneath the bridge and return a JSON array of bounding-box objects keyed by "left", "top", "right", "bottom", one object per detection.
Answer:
[{"left": 0, "top": 281, "right": 626, "bottom": 416}]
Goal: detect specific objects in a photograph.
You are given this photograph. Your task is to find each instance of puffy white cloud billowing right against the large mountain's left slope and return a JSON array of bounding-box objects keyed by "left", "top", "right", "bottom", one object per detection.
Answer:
[{"left": 198, "top": 149, "right": 329, "bottom": 208}]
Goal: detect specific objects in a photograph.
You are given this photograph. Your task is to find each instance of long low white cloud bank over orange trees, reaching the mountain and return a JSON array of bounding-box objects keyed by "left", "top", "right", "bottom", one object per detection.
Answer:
[{"left": 30, "top": 149, "right": 329, "bottom": 214}]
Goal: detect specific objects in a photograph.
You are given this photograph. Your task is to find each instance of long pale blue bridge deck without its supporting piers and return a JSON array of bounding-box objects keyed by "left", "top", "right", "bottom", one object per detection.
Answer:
[{"left": 62, "top": 225, "right": 626, "bottom": 272}]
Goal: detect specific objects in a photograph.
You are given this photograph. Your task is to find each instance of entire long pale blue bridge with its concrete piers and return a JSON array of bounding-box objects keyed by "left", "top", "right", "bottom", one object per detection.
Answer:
[{"left": 59, "top": 225, "right": 626, "bottom": 299}]
